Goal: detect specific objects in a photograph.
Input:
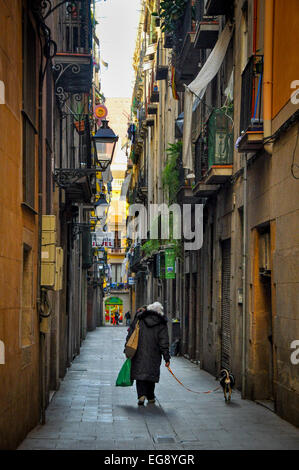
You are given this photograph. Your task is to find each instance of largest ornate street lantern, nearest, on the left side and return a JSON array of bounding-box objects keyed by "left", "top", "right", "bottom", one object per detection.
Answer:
[{"left": 92, "top": 119, "right": 118, "bottom": 171}]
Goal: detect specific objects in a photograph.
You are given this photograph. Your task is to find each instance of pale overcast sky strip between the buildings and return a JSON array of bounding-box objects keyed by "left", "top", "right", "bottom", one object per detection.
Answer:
[{"left": 96, "top": 0, "right": 141, "bottom": 98}]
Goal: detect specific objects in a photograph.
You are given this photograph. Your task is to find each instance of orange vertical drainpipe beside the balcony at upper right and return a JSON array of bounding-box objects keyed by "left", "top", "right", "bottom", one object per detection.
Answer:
[{"left": 264, "top": 0, "right": 274, "bottom": 155}]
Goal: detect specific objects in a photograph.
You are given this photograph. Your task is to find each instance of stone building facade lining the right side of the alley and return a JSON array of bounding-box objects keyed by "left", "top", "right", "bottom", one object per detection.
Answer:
[{"left": 129, "top": 0, "right": 299, "bottom": 425}]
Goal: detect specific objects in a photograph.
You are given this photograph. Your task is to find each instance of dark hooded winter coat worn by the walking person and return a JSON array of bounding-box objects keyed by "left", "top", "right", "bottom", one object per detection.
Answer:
[{"left": 126, "top": 304, "right": 170, "bottom": 382}]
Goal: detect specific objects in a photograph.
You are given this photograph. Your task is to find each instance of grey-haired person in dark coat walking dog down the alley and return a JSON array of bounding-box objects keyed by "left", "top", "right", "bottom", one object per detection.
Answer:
[{"left": 126, "top": 302, "right": 170, "bottom": 405}]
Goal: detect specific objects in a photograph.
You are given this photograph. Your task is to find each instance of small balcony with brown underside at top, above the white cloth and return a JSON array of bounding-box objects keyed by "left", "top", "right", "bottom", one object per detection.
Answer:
[{"left": 194, "top": 2, "right": 219, "bottom": 49}]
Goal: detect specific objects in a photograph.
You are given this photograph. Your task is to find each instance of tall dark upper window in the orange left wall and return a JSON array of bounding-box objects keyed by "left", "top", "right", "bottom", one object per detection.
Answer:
[{"left": 22, "top": 14, "right": 37, "bottom": 208}]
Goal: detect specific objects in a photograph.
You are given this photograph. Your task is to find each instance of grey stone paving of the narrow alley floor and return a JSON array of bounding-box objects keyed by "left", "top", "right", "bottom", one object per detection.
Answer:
[{"left": 19, "top": 326, "right": 299, "bottom": 450}]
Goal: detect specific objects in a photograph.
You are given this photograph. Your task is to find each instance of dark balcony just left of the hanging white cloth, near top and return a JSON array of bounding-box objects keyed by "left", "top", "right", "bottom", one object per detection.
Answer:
[{"left": 174, "top": 1, "right": 200, "bottom": 91}]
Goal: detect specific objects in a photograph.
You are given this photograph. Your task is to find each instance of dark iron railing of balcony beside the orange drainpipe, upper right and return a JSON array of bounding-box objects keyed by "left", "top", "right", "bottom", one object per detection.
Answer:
[{"left": 240, "top": 55, "right": 263, "bottom": 134}]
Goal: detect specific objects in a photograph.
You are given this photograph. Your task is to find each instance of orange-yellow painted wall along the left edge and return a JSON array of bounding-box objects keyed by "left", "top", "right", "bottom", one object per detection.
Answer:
[{"left": 0, "top": 0, "right": 39, "bottom": 449}]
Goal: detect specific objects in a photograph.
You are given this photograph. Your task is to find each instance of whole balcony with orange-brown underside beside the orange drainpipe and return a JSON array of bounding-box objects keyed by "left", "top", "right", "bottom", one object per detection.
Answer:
[{"left": 238, "top": 55, "right": 264, "bottom": 152}]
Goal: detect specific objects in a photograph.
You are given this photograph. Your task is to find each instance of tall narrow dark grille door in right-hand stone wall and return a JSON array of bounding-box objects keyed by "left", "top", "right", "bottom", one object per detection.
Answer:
[{"left": 221, "top": 239, "right": 231, "bottom": 370}]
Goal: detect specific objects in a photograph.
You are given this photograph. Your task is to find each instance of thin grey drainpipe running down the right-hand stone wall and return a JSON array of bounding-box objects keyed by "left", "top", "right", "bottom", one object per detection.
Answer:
[{"left": 242, "top": 153, "right": 247, "bottom": 399}]
